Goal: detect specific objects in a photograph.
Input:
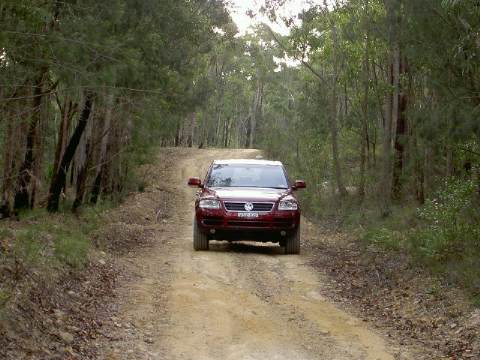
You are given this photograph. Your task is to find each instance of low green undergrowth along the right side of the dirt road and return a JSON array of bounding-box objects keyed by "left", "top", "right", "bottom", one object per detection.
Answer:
[{"left": 316, "top": 179, "right": 480, "bottom": 306}]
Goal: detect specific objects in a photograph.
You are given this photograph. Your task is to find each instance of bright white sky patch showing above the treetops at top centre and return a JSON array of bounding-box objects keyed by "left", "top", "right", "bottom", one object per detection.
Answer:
[{"left": 230, "top": 0, "right": 318, "bottom": 35}]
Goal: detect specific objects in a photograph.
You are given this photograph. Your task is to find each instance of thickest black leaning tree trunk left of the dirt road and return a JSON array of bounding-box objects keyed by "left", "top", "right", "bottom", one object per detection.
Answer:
[{"left": 47, "top": 92, "right": 93, "bottom": 212}]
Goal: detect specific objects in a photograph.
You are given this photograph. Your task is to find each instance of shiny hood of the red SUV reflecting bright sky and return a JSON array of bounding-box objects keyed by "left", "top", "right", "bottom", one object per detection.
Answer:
[{"left": 207, "top": 187, "right": 290, "bottom": 202}]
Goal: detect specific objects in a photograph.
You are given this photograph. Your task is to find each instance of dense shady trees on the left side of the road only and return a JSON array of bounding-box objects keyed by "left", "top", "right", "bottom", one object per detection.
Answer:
[{"left": 0, "top": 0, "right": 229, "bottom": 217}]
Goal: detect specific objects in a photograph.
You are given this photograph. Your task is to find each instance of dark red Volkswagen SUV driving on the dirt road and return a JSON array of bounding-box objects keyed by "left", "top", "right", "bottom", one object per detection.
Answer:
[{"left": 188, "top": 160, "right": 305, "bottom": 254}]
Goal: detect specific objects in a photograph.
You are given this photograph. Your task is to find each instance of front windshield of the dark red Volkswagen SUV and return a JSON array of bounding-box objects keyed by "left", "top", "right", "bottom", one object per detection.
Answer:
[{"left": 206, "top": 164, "right": 288, "bottom": 189}]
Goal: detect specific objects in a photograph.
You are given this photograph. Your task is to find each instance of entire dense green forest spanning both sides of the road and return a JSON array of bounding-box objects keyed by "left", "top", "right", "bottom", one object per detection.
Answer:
[{"left": 0, "top": 0, "right": 480, "bottom": 299}]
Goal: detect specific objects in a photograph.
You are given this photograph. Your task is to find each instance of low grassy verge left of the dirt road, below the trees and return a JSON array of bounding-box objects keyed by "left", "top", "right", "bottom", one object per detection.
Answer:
[{"left": 0, "top": 203, "right": 111, "bottom": 313}]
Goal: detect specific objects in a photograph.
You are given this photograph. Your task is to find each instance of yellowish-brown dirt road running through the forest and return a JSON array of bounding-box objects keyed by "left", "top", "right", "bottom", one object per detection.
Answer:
[{"left": 98, "top": 150, "right": 406, "bottom": 360}]
